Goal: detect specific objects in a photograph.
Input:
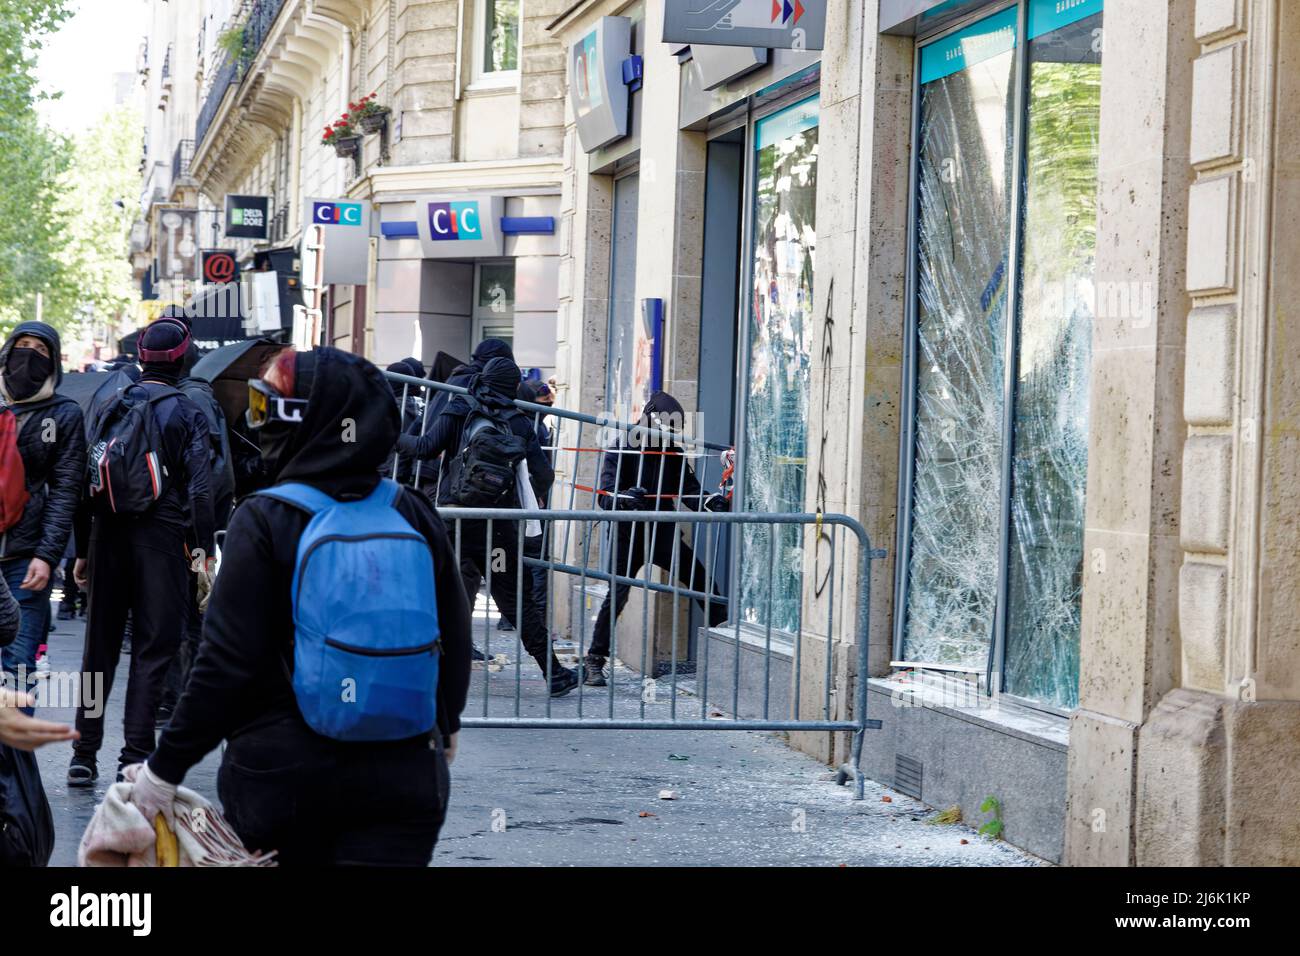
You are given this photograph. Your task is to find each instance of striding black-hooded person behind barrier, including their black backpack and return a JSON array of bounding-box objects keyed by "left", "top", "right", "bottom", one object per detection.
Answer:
[{"left": 398, "top": 356, "right": 579, "bottom": 697}]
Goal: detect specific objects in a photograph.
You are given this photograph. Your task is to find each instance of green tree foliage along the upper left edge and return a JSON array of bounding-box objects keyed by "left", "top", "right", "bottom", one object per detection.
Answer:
[{"left": 0, "top": 0, "right": 69, "bottom": 330}]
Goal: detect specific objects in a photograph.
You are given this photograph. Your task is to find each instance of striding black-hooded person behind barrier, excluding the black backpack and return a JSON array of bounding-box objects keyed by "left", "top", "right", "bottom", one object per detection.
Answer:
[{"left": 398, "top": 353, "right": 579, "bottom": 697}]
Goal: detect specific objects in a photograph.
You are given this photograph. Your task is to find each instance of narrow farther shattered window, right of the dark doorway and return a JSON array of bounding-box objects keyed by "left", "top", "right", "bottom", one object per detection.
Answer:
[{"left": 740, "top": 98, "right": 818, "bottom": 632}]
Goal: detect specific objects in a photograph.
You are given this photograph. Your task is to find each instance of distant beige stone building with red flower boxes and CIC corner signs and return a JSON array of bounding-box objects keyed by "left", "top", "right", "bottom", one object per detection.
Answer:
[{"left": 131, "top": 0, "right": 564, "bottom": 375}]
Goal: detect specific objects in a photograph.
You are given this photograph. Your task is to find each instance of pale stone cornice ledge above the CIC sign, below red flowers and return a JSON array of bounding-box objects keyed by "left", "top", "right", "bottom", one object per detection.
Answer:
[{"left": 348, "top": 156, "right": 564, "bottom": 202}]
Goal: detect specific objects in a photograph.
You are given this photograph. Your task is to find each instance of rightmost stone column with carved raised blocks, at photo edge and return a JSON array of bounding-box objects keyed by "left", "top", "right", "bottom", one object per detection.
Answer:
[{"left": 1136, "top": 0, "right": 1300, "bottom": 866}]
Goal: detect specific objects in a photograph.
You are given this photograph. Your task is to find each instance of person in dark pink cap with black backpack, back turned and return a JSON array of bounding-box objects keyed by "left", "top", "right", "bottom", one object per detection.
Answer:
[{"left": 68, "top": 319, "right": 215, "bottom": 787}]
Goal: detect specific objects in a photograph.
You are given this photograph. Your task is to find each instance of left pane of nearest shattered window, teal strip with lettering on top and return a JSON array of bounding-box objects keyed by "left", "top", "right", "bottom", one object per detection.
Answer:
[{"left": 902, "top": 8, "right": 1017, "bottom": 671}]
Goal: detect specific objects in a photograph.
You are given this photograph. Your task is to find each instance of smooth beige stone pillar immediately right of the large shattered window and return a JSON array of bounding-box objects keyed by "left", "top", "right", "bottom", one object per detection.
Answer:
[{"left": 1065, "top": 0, "right": 1195, "bottom": 865}]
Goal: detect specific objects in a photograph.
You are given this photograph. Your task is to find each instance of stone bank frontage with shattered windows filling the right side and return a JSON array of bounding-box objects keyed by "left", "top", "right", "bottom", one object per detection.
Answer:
[{"left": 547, "top": 0, "right": 1300, "bottom": 865}]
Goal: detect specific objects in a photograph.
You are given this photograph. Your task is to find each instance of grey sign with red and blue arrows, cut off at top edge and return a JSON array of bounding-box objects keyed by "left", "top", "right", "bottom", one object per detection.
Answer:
[{"left": 663, "top": 0, "right": 826, "bottom": 49}]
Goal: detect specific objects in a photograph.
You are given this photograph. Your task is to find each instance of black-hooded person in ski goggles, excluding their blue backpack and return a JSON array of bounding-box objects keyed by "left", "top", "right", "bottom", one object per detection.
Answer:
[{"left": 138, "top": 349, "right": 469, "bottom": 866}]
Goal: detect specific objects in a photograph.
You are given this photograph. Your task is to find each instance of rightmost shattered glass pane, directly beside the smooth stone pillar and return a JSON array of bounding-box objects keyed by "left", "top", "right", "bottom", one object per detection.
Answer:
[{"left": 1004, "top": 14, "right": 1101, "bottom": 708}]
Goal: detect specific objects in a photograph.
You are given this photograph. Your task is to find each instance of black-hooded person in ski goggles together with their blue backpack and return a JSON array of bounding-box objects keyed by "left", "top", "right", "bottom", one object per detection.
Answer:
[{"left": 131, "top": 349, "right": 471, "bottom": 866}]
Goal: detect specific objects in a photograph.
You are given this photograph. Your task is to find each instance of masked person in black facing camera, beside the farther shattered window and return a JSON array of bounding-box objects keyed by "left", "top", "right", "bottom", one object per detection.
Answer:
[{"left": 584, "top": 392, "right": 729, "bottom": 687}]
